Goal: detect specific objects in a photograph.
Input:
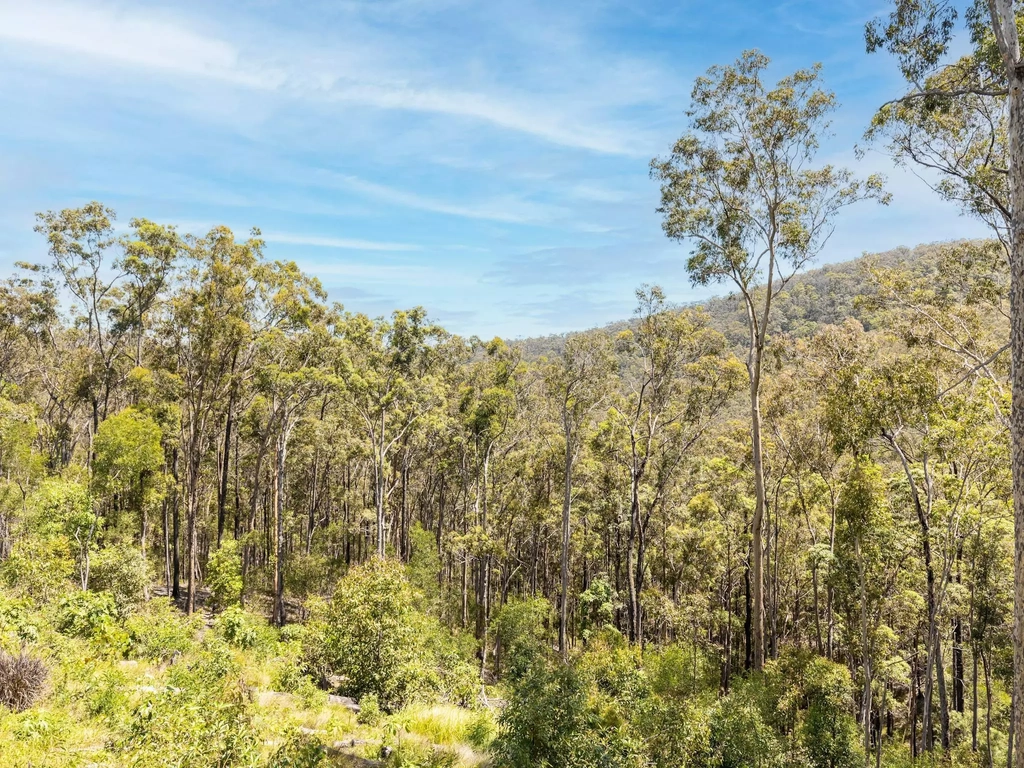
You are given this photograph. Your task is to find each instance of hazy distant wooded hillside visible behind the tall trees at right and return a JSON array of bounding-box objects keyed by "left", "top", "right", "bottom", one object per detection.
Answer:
[{"left": 515, "top": 243, "right": 951, "bottom": 358}]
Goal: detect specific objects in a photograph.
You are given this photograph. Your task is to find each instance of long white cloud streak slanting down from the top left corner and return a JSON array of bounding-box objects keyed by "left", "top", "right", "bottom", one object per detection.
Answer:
[{"left": 0, "top": 0, "right": 643, "bottom": 155}]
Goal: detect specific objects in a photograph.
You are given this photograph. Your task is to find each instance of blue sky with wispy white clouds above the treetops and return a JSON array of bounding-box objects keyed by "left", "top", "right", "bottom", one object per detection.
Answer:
[{"left": 0, "top": 0, "right": 984, "bottom": 338}]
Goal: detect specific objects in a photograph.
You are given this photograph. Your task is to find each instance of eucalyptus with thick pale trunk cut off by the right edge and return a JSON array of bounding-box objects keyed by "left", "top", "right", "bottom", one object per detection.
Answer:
[{"left": 866, "top": 0, "right": 1024, "bottom": 753}]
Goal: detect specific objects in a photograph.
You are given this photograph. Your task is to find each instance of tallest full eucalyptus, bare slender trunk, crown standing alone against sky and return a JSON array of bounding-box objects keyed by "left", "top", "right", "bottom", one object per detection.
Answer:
[{"left": 651, "top": 51, "right": 888, "bottom": 669}]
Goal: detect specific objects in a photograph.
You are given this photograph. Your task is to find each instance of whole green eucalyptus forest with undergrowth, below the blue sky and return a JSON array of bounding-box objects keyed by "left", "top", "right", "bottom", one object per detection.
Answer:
[{"left": 6, "top": 0, "right": 1024, "bottom": 768}]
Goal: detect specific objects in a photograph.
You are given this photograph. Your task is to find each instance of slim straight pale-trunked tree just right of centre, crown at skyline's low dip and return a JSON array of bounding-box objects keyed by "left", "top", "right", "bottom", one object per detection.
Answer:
[{"left": 545, "top": 332, "right": 615, "bottom": 657}]
